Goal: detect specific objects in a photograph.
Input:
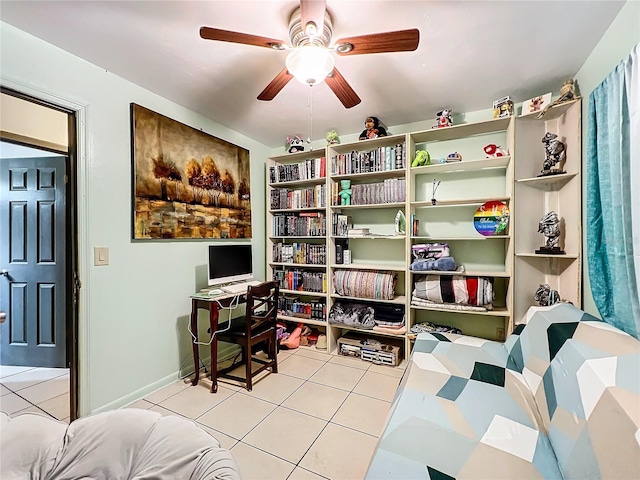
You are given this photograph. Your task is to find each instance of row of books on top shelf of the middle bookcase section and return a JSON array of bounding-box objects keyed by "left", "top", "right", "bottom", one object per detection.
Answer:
[{"left": 331, "top": 142, "right": 407, "bottom": 175}]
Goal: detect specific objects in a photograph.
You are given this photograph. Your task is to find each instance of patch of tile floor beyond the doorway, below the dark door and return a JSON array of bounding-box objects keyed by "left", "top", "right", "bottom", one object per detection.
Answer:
[{"left": 0, "top": 365, "right": 71, "bottom": 422}]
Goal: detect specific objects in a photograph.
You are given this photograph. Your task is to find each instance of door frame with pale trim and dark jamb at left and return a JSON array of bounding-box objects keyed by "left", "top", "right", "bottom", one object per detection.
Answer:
[{"left": 0, "top": 82, "right": 91, "bottom": 420}]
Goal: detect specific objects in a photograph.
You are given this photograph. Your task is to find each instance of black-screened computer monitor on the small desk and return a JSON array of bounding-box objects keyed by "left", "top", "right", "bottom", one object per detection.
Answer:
[{"left": 209, "top": 244, "right": 253, "bottom": 285}]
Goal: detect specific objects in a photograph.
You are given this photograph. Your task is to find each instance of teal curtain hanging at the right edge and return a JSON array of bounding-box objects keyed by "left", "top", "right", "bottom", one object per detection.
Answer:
[{"left": 586, "top": 45, "right": 640, "bottom": 338}]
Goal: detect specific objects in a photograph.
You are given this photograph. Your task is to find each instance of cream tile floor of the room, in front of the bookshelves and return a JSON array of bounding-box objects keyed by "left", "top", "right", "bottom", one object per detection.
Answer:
[{"left": 134, "top": 347, "right": 404, "bottom": 480}]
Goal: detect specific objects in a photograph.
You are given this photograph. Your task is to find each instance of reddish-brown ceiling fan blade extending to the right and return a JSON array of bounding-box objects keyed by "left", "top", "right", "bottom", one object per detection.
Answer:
[{"left": 336, "top": 28, "right": 420, "bottom": 55}]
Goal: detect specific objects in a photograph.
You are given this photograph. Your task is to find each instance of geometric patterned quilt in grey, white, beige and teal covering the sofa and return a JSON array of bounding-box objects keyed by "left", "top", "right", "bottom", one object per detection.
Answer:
[{"left": 366, "top": 304, "right": 640, "bottom": 480}]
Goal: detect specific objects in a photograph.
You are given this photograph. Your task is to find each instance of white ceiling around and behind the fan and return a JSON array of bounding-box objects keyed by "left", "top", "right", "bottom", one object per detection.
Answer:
[{"left": 0, "top": 0, "right": 625, "bottom": 147}]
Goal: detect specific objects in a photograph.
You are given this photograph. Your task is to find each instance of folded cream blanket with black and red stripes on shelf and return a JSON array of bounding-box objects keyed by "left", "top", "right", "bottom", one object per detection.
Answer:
[{"left": 413, "top": 275, "right": 493, "bottom": 305}]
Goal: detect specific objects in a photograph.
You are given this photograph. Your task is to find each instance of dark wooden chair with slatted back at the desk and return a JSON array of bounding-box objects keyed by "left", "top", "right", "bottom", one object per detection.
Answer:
[{"left": 217, "top": 281, "right": 280, "bottom": 391}]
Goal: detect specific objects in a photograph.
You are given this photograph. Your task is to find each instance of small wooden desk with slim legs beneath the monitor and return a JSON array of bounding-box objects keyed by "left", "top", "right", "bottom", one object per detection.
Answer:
[{"left": 191, "top": 293, "right": 247, "bottom": 393}]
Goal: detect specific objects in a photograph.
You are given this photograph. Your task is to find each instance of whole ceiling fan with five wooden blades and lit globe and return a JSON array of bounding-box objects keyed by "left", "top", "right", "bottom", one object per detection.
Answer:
[{"left": 200, "top": 0, "right": 420, "bottom": 108}]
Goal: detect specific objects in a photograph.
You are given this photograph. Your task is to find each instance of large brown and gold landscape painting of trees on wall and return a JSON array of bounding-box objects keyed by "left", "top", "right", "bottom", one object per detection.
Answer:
[{"left": 130, "top": 102, "right": 251, "bottom": 240}]
